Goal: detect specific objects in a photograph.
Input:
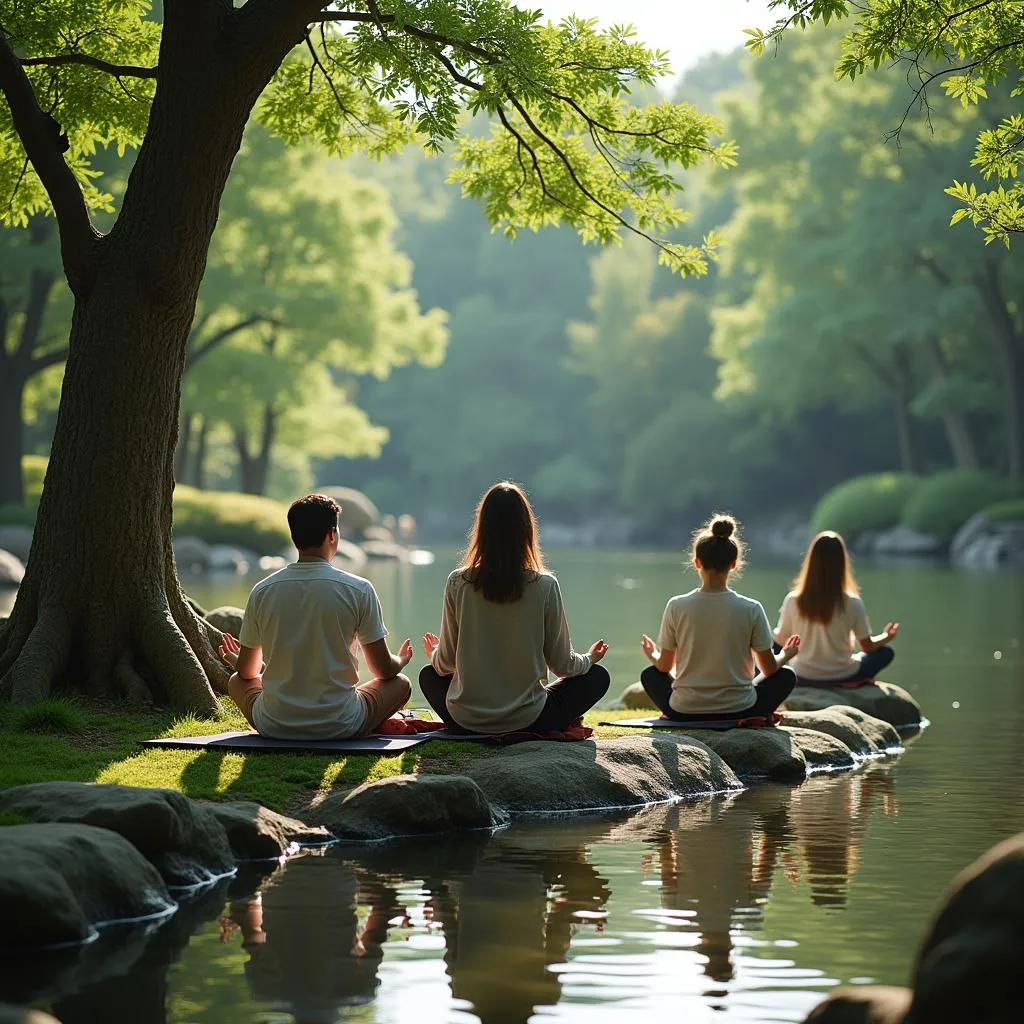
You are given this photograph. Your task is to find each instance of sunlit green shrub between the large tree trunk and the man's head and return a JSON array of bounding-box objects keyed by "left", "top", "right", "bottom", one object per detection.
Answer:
[{"left": 174, "top": 483, "right": 292, "bottom": 555}]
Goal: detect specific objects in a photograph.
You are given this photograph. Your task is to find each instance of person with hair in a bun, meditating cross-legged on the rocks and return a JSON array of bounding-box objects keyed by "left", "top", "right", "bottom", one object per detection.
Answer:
[{"left": 640, "top": 515, "right": 800, "bottom": 722}]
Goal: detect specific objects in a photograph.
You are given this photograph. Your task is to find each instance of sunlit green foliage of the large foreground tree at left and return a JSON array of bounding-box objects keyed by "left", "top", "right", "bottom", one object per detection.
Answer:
[{"left": 0, "top": 0, "right": 734, "bottom": 273}]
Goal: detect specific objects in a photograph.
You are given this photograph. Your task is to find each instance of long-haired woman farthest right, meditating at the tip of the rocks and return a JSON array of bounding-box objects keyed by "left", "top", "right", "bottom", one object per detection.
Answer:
[{"left": 775, "top": 531, "right": 899, "bottom": 686}]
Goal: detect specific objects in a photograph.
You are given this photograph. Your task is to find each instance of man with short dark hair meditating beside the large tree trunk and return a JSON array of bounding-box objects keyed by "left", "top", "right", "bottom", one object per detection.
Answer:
[{"left": 220, "top": 495, "right": 413, "bottom": 739}]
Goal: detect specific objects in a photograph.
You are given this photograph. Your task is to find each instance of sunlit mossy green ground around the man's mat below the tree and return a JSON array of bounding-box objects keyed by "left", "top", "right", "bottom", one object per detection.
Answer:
[{"left": 0, "top": 697, "right": 636, "bottom": 812}]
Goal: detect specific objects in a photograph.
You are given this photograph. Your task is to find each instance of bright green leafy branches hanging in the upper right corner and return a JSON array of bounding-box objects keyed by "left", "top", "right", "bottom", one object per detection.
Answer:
[{"left": 748, "top": 0, "right": 1024, "bottom": 246}]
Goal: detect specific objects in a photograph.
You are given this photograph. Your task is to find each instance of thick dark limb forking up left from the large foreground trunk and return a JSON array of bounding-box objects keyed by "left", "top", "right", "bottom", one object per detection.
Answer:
[{"left": 0, "top": 30, "right": 99, "bottom": 294}]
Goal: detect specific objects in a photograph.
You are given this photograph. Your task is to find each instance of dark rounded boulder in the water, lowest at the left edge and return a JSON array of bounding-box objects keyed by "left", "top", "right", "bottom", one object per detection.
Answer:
[{"left": 0, "top": 824, "right": 174, "bottom": 952}]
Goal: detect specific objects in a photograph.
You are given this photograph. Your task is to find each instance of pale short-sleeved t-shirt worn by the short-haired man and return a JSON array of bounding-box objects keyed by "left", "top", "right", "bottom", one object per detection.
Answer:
[{"left": 239, "top": 559, "right": 387, "bottom": 739}]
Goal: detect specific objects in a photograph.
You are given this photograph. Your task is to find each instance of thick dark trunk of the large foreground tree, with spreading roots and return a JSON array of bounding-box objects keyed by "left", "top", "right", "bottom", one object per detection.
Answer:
[{"left": 0, "top": 3, "right": 304, "bottom": 714}]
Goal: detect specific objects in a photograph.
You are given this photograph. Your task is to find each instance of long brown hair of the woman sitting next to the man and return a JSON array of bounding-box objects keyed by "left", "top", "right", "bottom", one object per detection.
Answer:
[{"left": 460, "top": 480, "right": 545, "bottom": 604}]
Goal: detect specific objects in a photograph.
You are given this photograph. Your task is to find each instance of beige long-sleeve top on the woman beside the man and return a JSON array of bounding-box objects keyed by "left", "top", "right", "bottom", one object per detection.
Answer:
[{"left": 431, "top": 569, "right": 590, "bottom": 732}]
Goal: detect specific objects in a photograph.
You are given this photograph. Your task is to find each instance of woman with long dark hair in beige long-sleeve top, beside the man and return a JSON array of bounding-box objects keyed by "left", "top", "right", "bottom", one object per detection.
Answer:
[{"left": 420, "top": 480, "right": 610, "bottom": 734}]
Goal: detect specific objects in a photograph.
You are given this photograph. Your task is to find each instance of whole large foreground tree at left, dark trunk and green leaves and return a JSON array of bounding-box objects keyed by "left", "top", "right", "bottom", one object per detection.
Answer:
[{"left": 0, "top": 0, "right": 732, "bottom": 713}]
